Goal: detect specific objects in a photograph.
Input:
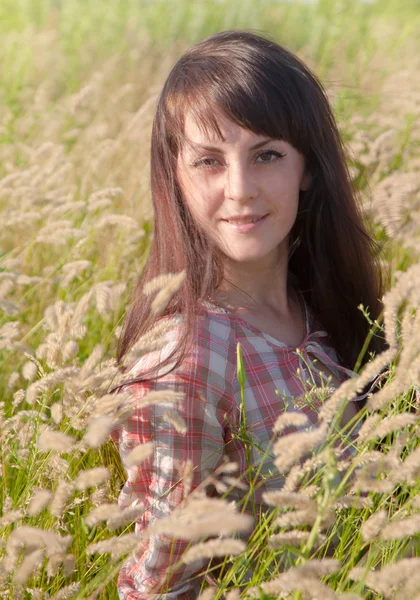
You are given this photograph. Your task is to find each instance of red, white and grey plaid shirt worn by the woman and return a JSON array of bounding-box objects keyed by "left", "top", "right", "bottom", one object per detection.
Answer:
[{"left": 113, "top": 302, "right": 360, "bottom": 600}]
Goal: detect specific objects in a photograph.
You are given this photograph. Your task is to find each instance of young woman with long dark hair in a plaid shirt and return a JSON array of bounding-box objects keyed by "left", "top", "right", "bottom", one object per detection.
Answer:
[{"left": 113, "top": 31, "right": 383, "bottom": 600}]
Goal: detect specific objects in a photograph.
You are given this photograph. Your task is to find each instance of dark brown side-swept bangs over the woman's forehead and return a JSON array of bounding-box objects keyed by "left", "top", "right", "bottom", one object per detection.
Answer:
[{"left": 166, "top": 50, "right": 309, "bottom": 154}]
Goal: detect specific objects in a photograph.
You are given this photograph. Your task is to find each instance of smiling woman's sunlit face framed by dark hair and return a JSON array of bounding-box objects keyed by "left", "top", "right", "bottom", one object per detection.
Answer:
[{"left": 177, "top": 116, "right": 309, "bottom": 265}]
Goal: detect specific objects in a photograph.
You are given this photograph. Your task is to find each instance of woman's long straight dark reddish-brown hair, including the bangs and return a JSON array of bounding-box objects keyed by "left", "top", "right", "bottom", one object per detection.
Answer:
[{"left": 118, "top": 31, "right": 384, "bottom": 378}]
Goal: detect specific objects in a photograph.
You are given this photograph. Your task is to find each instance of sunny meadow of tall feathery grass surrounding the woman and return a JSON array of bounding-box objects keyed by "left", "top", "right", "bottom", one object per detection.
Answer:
[{"left": 0, "top": 0, "right": 420, "bottom": 600}]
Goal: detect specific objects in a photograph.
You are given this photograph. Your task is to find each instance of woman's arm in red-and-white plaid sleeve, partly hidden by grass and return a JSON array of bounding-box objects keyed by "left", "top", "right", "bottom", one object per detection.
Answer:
[{"left": 113, "top": 374, "right": 228, "bottom": 600}]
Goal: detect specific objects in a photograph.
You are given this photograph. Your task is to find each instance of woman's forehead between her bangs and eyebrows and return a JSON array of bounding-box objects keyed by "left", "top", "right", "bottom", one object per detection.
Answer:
[{"left": 184, "top": 113, "right": 267, "bottom": 147}]
